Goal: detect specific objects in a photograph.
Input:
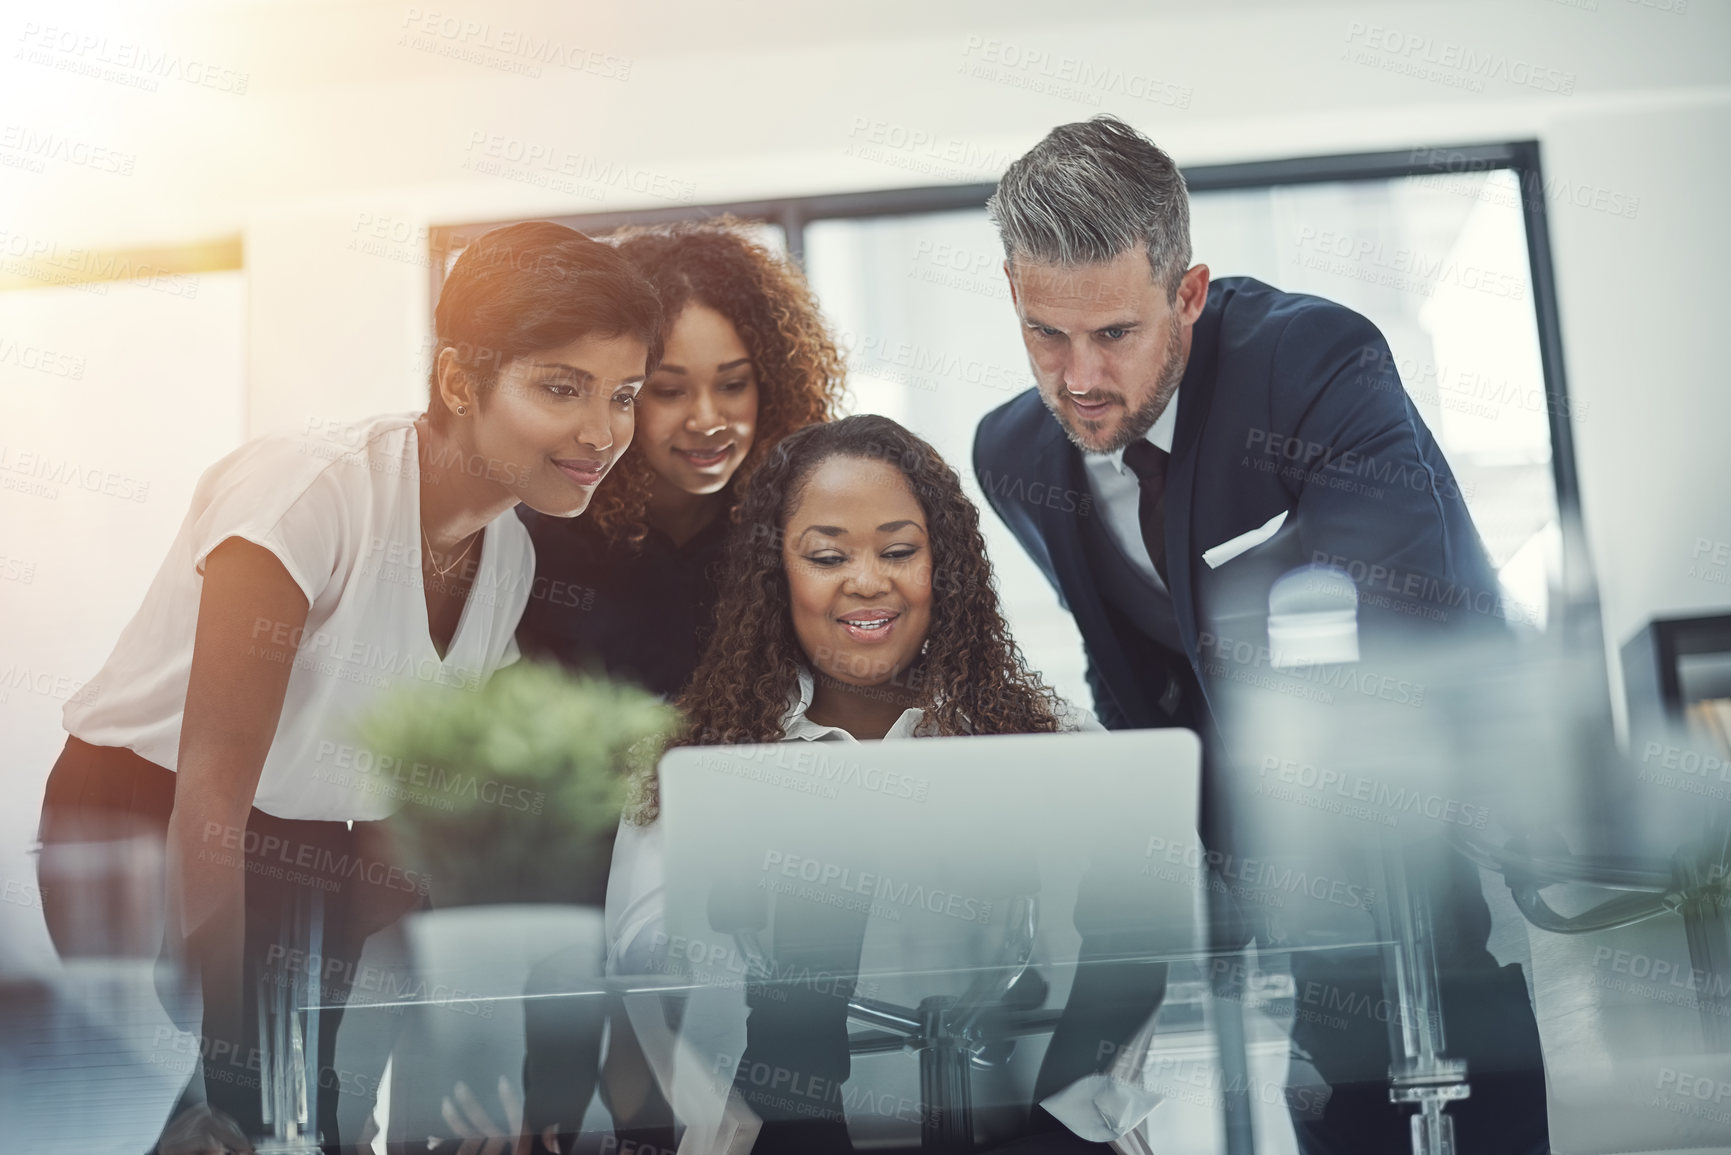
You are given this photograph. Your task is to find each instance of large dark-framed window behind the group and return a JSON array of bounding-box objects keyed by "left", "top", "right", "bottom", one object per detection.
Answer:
[{"left": 434, "top": 144, "right": 1596, "bottom": 701}]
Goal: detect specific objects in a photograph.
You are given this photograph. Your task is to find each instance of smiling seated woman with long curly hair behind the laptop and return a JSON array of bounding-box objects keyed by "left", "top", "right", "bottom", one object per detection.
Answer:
[{"left": 608, "top": 416, "right": 1099, "bottom": 1152}]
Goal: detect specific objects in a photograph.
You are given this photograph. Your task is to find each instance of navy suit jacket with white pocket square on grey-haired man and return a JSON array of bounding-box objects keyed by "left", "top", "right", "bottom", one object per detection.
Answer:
[{"left": 975, "top": 277, "right": 1506, "bottom": 729}]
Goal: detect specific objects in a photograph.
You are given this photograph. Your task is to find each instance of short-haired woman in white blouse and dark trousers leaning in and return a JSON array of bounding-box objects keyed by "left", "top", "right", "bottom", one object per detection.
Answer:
[{"left": 42, "top": 222, "right": 661, "bottom": 1150}]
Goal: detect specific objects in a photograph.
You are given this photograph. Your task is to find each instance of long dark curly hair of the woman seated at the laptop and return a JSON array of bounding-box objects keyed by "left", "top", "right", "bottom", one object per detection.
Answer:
[{"left": 628, "top": 414, "right": 1061, "bottom": 824}]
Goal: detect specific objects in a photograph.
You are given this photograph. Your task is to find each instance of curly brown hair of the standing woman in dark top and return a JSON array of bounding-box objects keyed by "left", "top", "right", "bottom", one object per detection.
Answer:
[{"left": 589, "top": 216, "right": 846, "bottom": 544}]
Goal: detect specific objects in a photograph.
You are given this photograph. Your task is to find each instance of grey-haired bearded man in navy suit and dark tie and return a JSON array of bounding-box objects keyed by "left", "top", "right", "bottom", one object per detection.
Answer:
[{"left": 975, "top": 116, "right": 1548, "bottom": 1153}]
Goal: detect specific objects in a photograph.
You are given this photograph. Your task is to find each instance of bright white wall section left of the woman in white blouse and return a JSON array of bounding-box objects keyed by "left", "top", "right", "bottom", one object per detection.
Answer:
[{"left": 0, "top": 272, "right": 246, "bottom": 971}]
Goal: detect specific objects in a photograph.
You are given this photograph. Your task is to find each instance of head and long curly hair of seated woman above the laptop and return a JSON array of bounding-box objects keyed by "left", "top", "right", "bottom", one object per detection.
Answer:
[{"left": 657, "top": 414, "right": 1063, "bottom": 758}]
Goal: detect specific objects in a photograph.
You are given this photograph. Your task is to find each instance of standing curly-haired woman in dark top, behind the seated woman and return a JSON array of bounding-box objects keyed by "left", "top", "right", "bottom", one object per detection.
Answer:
[{"left": 519, "top": 220, "right": 845, "bottom": 698}]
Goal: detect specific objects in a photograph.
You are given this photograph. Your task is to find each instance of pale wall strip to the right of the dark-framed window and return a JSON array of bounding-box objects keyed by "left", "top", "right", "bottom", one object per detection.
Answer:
[{"left": 1546, "top": 99, "right": 1731, "bottom": 668}]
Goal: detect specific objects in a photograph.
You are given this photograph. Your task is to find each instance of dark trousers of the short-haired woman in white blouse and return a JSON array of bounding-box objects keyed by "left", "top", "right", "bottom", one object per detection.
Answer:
[{"left": 40, "top": 738, "right": 424, "bottom": 1150}]
